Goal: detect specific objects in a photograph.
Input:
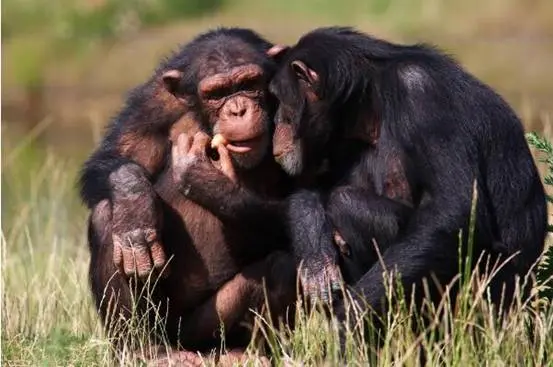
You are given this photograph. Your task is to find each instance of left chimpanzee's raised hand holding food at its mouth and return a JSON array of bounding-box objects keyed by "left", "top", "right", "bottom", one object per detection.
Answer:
[{"left": 172, "top": 132, "right": 236, "bottom": 195}]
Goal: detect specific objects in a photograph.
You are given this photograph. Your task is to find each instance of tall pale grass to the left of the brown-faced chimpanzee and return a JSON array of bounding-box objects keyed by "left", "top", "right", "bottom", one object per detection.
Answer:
[{"left": 2, "top": 142, "right": 105, "bottom": 366}]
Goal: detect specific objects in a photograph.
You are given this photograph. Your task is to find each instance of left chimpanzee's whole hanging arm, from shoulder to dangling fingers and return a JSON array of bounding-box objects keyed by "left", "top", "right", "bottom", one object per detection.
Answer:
[{"left": 80, "top": 120, "right": 168, "bottom": 276}]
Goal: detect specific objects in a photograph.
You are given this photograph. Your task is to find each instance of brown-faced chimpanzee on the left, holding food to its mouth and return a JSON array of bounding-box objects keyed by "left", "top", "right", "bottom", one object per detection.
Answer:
[{"left": 77, "top": 28, "right": 296, "bottom": 362}]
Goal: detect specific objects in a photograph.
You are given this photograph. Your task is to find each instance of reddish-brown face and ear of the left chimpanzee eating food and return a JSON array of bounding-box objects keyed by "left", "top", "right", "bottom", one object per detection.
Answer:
[{"left": 163, "top": 42, "right": 272, "bottom": 169}]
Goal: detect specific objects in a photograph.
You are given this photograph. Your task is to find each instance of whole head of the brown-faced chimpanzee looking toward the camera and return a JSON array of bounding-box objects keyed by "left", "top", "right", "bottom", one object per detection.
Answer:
[{"left": 160, "top": 28, "right": 276, "bottom": 169}]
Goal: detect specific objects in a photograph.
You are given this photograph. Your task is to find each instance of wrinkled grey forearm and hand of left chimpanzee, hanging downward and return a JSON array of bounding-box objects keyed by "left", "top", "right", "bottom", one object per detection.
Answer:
[{"left": 109, "top": 164, "right": 168, "bottom": 278}]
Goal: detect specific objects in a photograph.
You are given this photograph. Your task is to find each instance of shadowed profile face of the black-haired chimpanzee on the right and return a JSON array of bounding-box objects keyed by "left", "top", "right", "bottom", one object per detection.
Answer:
[{"left": 269, "top": 46, "right": 332, "bottom": 176}]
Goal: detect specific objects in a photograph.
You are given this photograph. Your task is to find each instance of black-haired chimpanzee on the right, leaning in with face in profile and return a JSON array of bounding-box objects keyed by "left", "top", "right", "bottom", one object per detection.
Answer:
[{"left": 269, "top": 27, "right": 546, "bottom": 332}]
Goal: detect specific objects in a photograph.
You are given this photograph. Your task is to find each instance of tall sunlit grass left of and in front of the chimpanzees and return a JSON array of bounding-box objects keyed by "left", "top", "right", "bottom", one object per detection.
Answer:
[{"left": 1, "top": 133, "right": 553, "bottom": 366}]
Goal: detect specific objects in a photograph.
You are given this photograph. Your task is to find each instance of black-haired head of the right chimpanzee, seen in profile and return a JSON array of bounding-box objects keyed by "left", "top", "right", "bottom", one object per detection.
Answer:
[{"left": 268, "top": 28, "right": 375, "bottom": 175}]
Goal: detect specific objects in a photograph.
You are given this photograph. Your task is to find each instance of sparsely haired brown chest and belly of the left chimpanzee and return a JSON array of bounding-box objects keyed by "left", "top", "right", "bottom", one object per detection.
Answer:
[{"left": 156, "top": 175, "right": 265, "bottom": 305}]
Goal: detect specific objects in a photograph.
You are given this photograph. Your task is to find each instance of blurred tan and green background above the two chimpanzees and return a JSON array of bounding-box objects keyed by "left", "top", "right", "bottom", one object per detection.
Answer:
[{"left": 2, "top": 0, "right": 553, "bottom": 158}]
